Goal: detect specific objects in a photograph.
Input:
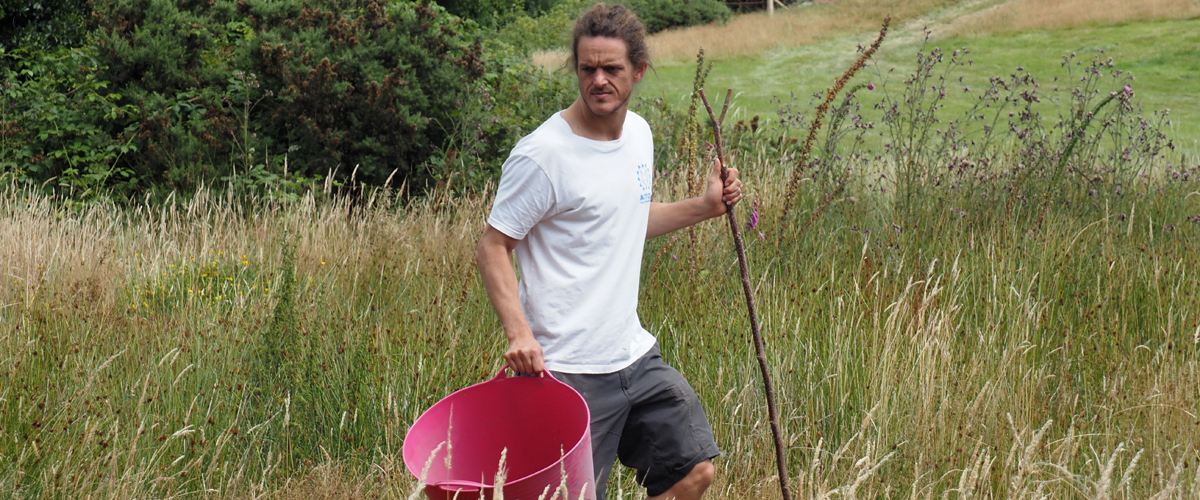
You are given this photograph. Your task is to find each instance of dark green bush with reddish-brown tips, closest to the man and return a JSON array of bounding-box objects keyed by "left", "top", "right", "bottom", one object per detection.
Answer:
[{"left": 245, "top": 0, "right": 485, "bottom": 188}]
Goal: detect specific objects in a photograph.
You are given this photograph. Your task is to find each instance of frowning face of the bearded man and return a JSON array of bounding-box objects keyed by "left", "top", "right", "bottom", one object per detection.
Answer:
[{"left": 575, "top": 36, "right": 646, "bottom": 116}]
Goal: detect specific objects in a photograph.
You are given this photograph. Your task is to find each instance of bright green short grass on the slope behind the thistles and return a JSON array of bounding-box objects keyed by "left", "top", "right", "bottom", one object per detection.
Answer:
[{"left": 640, "top": 19, "right": 1200, "bottom": 151}]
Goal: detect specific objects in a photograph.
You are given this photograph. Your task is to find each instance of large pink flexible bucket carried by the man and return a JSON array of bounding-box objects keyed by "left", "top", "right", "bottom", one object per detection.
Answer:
[{"left": 404, "top": 367, "right": 595, "bottom": 500}]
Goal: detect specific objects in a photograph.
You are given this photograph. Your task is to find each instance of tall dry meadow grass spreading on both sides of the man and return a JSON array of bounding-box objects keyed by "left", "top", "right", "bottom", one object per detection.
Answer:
[{"left": 0, "top": 143, "right": 1200, "bottom": 499}]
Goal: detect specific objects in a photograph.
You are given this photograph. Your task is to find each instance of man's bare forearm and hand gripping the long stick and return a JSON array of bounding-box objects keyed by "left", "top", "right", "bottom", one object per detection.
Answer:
[{"left": 646, "top": 162, "right": 742, "bottom": 240}]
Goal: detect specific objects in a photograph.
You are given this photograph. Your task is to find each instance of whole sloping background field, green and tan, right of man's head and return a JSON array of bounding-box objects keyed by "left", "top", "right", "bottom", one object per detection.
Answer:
[{"left": 619, "top": 0, "right": 1200, "bottom": 146}]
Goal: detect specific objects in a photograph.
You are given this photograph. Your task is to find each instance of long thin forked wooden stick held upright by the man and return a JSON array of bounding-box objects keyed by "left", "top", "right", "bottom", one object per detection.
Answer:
[{"left": 700, "top": 89, "right": 792, "bottom": 500}]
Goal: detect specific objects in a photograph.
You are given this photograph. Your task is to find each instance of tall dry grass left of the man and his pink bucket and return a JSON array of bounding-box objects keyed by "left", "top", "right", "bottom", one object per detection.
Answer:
[{"left": 0, "top": 189, "right": 494, "bottom": 498}]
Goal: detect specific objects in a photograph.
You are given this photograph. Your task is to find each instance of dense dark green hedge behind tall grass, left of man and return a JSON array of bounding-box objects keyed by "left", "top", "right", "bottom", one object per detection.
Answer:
[{"left": 0, "top": 0, "right": 572, "bottom": 199}]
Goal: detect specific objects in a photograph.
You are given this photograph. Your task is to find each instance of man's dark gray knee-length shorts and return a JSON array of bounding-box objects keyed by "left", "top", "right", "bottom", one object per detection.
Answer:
[{"left": 553, "top": 345, "right": 721, "bottom": 500}]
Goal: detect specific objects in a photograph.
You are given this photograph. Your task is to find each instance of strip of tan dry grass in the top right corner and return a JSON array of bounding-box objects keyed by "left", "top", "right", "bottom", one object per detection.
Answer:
[{"left": 949, "top": 0, "right": 1200, "bottom": 35}]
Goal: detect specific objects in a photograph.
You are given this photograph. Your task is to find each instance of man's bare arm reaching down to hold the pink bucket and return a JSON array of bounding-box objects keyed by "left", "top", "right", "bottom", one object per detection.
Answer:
[{"left": 475, "top": 224, "right": 545, "bottom": 373}]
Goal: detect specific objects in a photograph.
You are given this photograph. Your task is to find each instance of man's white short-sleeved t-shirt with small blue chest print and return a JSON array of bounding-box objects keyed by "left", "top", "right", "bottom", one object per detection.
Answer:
[{"left": 487, "top": 112, "right": 655, "bottom": 373}]
